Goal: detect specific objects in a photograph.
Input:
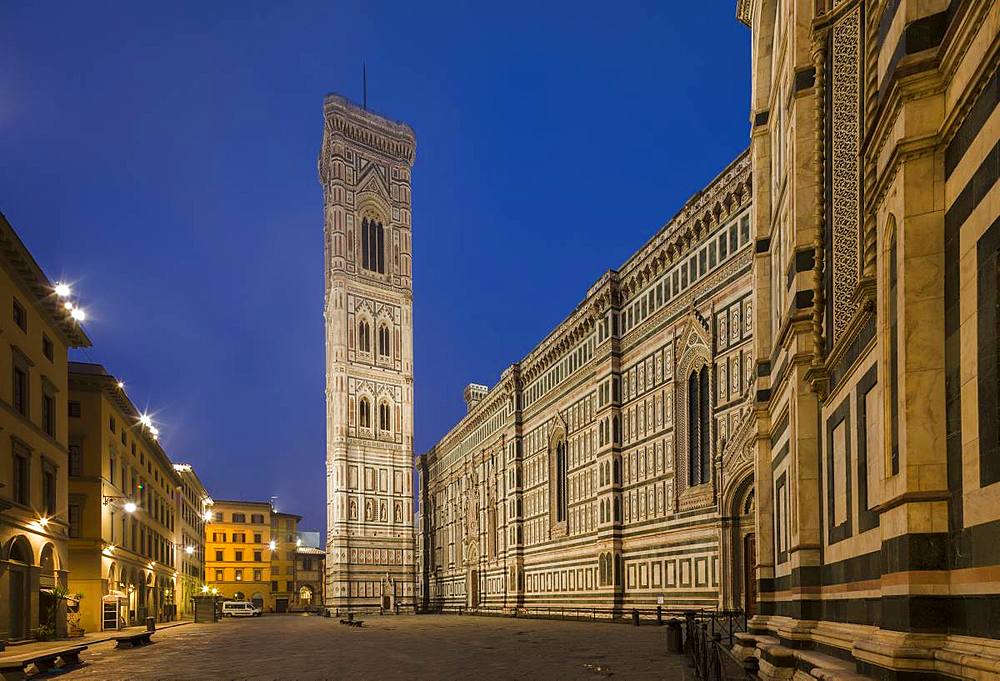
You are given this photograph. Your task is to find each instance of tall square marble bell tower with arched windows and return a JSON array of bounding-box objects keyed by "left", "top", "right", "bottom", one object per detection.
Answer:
[{"left": 318, "top": 95, "right": 416, "bottom": 613}]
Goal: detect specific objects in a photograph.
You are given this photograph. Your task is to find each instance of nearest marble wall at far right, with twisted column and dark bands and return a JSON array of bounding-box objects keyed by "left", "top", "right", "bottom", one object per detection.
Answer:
[{"left": 738, "top": 0, "right": 1000, "bottom": 680}]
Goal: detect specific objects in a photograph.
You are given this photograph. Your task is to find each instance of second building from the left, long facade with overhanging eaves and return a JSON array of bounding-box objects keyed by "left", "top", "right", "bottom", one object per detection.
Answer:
[{"left": 68, "top": 362, "right": 182, "bottom": 631}]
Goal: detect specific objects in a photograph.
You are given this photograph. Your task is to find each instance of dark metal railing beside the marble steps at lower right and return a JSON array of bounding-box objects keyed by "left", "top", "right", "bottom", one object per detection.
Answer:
[{"left": 684, "top": 611, "right": 757, "bottom": 681}]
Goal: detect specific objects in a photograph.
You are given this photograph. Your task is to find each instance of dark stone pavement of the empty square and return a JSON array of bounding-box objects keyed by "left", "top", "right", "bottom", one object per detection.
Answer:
[{"left": 59, "top": 615, "right": 694, "bottom": 681}]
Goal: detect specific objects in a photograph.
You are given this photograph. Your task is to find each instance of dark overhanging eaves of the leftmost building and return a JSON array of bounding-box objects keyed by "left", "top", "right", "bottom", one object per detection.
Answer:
[{"left": 0, "top": 213, "right": 91, "bottom": 348}]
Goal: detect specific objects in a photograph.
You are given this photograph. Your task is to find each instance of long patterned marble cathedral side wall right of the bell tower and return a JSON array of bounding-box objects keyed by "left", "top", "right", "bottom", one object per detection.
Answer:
[{"left": 417, "top": 154, "right": 756, "bottom": 615}]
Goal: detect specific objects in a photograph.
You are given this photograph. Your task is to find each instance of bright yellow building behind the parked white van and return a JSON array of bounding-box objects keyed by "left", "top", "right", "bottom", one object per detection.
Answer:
[{"left": 205, "top": 501, "right": 302, "bottom": 612}]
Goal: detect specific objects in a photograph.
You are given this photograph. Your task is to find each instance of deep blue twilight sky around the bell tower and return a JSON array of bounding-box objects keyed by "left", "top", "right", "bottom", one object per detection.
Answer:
[{"left": 0, "top": 0, "right": 750, "bottom": 529}]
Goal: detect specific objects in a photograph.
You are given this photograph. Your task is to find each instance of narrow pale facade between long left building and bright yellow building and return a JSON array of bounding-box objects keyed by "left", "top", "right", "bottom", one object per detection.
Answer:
[{"left": 174, "top": 463, "right": 212, "bottom": 618}]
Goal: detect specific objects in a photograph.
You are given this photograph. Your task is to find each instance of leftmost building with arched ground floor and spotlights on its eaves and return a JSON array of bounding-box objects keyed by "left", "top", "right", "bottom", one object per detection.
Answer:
[{"left": 0, "top": 215, "right": 90, "bottom": 640}]
